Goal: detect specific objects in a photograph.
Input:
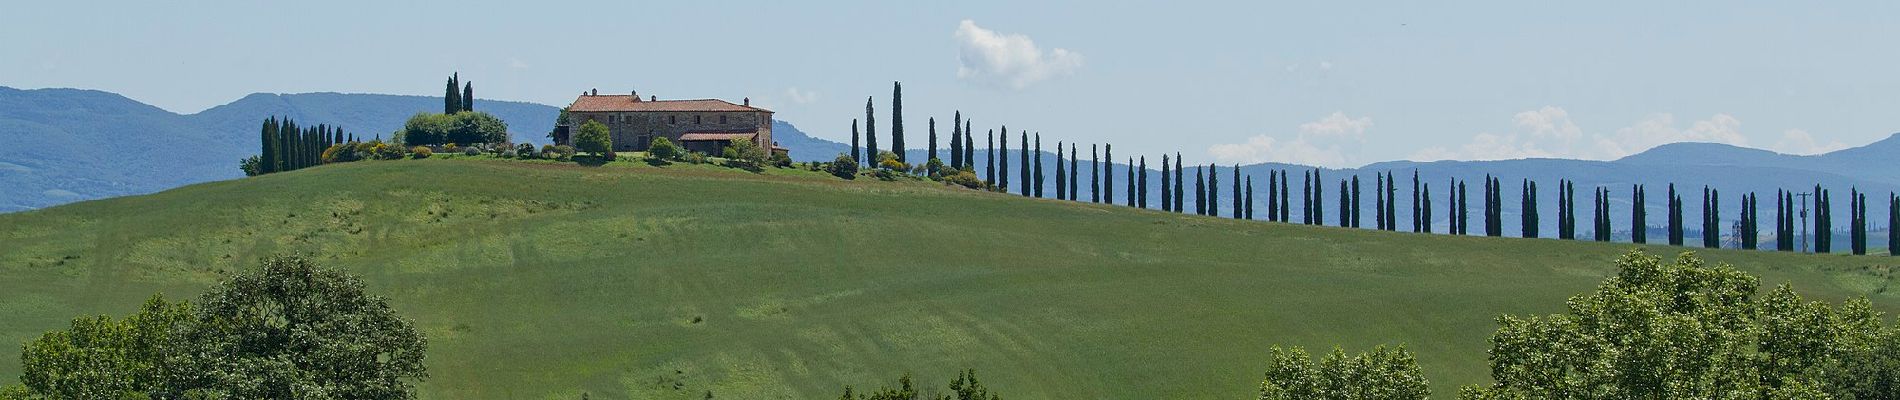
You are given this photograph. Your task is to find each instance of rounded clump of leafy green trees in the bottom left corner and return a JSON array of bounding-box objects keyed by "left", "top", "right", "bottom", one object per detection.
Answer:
[{"left": 0, "top": 256, "right": 428, "bottom": 400}]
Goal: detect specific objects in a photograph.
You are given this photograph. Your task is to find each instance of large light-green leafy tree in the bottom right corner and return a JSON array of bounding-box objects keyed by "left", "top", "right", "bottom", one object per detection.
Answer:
[{"left": 1459, "top": 250, "right": 1900, "bottom": 400}]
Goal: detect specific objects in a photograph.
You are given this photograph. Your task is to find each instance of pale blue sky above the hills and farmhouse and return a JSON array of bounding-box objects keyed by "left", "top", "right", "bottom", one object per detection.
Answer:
[{"left": 0, "top": 0, "right": 1900, "bottom": 167}]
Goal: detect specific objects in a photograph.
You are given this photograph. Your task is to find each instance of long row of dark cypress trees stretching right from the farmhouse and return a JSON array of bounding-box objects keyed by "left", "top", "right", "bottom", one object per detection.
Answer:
[{"left": 843, "top": 78, "right": 1900, "bottom": 254}]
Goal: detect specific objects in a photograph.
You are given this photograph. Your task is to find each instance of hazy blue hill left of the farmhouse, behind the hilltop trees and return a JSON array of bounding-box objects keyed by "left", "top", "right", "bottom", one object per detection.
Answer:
[{"left": 0, "top": 87, "right": 561, "bottom": 212}]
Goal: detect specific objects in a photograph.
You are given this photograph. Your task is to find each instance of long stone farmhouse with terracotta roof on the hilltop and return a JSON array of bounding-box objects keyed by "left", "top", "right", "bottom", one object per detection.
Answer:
[{"left": 555, "top": 89, "right": 787, "bottom": 155}]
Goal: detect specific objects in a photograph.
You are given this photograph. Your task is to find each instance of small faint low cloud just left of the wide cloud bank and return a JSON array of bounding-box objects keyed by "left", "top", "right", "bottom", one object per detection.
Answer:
[{"left": 1207, "top": 112, "right": 1372, "bottom": 167}]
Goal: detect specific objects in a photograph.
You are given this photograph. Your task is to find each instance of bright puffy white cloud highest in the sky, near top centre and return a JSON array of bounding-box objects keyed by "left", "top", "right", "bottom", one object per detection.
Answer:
[{"left": 954, "top": 19, "right": 1083, "bottom": 89}]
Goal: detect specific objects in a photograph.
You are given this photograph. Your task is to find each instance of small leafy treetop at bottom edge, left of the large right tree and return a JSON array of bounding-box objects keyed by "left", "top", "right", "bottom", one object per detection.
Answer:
[{"left": 1260, "top": 345, "right": 1431, "bottom": 400}]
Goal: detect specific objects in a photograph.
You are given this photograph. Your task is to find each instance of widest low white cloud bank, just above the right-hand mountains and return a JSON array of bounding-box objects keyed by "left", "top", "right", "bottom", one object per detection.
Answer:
[{"left": 1412, "top": 106, "right": 1748, "bottom": 161}]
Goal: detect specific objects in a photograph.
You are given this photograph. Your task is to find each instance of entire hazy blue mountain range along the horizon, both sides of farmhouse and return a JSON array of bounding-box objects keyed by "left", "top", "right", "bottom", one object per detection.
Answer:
[{"left": 0, "top": 87, "right": 1900, "bottom": 244}]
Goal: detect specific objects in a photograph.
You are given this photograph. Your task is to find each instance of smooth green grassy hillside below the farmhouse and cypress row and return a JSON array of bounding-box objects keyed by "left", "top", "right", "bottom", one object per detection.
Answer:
[{"left": 0, "top": 159, "right": 1900, "bottom": 398}]
